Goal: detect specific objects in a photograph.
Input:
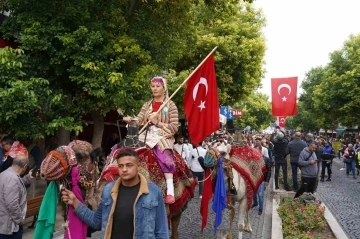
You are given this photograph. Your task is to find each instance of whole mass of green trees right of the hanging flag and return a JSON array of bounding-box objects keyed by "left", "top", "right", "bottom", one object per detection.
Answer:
[{"left": 294, "top": 35, "right": 360, "bottom": 129}]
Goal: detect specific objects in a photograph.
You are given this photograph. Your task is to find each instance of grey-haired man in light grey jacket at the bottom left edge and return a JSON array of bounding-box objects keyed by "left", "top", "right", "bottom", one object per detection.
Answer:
[{"left": 0, "top": 154, "right": 32, "bottom": 239}]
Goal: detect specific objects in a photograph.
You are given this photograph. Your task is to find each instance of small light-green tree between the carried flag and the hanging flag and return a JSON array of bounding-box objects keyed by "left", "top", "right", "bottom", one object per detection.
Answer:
[{"left": 233, "top": 92, "right": 274, "bottom": 130}]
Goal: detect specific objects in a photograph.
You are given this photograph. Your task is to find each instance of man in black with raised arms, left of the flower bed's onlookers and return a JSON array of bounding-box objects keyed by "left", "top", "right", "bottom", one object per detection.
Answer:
[{"left": 271, "top": 129, "right": 290, "bottom": 191}]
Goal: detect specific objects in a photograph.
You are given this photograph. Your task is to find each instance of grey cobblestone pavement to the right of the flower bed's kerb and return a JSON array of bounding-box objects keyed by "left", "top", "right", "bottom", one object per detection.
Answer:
[{"left": 317, "top": 159, "right": 360, "bottom": 239}]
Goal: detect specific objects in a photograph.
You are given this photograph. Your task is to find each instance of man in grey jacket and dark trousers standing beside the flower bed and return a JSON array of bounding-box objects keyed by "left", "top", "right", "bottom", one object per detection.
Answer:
[{"left": 295, "top": 141, "right": 318, "bottom": 198}]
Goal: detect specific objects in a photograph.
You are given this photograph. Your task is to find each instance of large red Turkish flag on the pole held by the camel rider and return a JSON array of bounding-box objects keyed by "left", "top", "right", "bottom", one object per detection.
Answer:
[{"left": 184, "top": 54, "right": 220, "bottom": 144}]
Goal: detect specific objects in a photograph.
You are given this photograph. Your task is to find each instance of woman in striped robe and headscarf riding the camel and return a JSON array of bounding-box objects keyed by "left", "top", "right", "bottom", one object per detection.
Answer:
[{"left": 123, "top": 77, "right": 179, "bottom": 204}]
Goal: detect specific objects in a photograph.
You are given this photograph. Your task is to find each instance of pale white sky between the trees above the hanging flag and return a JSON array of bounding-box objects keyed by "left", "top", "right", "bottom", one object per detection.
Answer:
[{"left": 255, "top": 0, "right": 360, "bottom": 99}]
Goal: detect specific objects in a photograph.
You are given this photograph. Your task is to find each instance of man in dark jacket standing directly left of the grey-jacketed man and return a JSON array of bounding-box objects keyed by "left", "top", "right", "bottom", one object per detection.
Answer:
[{"left": 286, "top": 132, "right": 307, "bottom": 192}]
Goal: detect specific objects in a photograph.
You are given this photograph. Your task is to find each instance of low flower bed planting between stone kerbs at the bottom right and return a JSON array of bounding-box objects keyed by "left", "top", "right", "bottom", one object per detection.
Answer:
[{"left": 278, "top": 197, "right": 328, "bottom": 239}]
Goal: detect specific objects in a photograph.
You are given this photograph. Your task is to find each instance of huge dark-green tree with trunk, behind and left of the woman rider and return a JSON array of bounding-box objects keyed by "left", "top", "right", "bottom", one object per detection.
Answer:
[{"left": 2, "top": 0, "right": 197, "bottom": 146}]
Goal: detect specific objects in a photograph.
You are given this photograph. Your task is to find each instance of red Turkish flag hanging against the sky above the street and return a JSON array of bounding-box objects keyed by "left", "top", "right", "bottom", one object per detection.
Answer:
[{"left": 271, "top": 77, "right": 297, "bottom": 116}]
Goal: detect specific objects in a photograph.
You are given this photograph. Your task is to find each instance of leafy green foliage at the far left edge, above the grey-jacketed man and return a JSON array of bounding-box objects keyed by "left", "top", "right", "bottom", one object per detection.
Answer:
[{"left": 0, "top": 47, "right": 51, "bottom": 138}]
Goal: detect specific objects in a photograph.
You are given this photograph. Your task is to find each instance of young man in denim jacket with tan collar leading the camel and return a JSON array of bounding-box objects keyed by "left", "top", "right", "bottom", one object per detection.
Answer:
[{"left": 62, "top": 149, "right": 169, "bottom": 239}]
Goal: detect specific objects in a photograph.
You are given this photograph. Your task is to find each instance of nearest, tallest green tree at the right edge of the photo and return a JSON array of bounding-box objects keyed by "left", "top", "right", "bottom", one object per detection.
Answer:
[{"left": 314, "top": 35, "right": 360, "bottom": 126}]
